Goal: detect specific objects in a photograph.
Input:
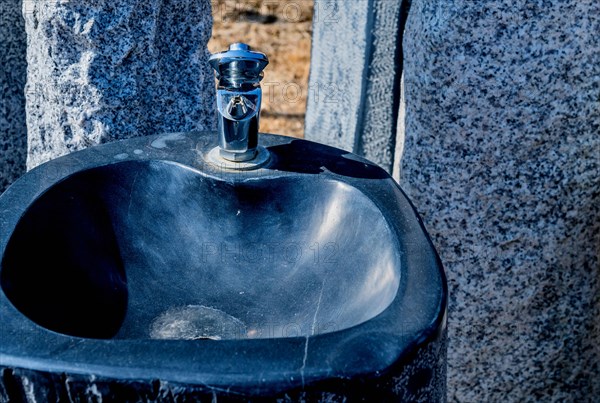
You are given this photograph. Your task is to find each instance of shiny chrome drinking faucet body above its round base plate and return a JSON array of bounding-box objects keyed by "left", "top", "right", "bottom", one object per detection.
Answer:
[{"left": 209, "top": 43, "right": 269, "bottom": 163}]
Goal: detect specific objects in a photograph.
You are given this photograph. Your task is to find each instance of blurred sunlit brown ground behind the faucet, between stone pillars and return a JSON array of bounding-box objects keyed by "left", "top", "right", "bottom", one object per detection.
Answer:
[{"left": 208, "top": 0, "right": 313, "bottom": 137}]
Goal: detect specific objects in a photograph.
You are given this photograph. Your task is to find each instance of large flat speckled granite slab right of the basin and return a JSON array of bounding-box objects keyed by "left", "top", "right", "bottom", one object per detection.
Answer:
[{"left": 400, "top": 0, "right": 600, "bottom": 402}]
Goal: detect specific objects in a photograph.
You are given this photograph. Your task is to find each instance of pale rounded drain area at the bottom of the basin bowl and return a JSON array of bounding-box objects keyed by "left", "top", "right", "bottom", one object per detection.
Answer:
[{"left": 150, "top": 305, "right": 246, "bottom": 340}]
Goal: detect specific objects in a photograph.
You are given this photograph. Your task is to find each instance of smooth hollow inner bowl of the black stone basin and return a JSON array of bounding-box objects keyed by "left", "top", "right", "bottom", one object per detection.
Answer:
[{"left": 1, "top": 161, "right": 400, "bottom": 339}]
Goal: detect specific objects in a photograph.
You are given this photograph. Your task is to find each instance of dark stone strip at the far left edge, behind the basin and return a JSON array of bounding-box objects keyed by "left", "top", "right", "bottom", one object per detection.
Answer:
[{"left": 0, "top": 0, "right": 27, "bottom": 193}]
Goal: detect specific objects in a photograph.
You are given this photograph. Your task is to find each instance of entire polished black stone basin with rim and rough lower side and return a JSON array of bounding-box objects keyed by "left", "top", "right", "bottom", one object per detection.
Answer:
[{"left": 0, "top": 133, "right": 446, "bottom": 401}]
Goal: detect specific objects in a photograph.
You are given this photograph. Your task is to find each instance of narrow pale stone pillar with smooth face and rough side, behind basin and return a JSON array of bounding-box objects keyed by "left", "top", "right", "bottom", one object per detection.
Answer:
[{"left": 305, "top": 0, "right": 404, "bottom": 171}]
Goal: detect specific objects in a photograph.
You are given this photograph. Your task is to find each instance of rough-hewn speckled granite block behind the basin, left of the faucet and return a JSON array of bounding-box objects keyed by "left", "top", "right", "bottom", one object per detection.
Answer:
[{"left": 23, "top": 0, "right": 215, "bottom": 168}]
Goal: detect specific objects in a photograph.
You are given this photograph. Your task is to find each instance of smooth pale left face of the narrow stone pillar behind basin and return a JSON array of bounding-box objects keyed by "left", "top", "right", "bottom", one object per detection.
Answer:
[{"left": 304, "top": 0, "right": 369, "bottom": 151}]
